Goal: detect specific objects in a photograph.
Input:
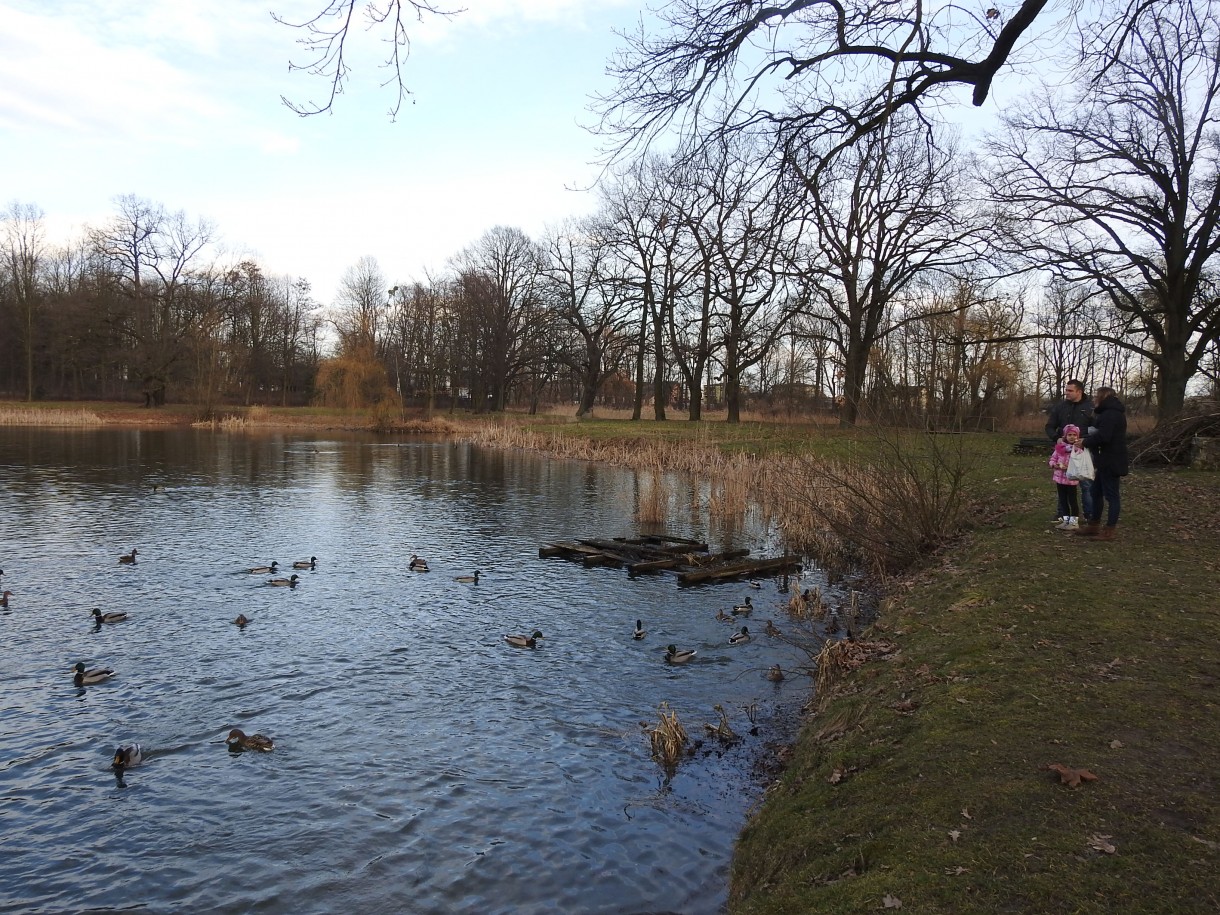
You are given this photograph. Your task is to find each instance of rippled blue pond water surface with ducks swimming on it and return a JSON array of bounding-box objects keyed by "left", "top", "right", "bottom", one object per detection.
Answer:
[{"left": 0, "top": 428, "right": 809, "bottom": 913}]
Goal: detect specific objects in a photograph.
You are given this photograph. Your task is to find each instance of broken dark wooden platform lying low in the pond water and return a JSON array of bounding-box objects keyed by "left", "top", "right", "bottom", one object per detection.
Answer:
[{"left": 538, "top": 534, "right": 800, "bottom": 584}]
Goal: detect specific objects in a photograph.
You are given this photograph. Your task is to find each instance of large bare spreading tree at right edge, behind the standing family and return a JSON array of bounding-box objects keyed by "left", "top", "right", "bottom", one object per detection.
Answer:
[{"left": 992, "top": 0, "right": 1220, "bottom": 420}]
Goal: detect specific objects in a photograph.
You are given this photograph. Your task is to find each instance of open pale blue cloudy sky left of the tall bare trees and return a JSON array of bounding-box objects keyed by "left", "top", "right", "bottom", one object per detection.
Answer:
[{"left": 0, "top": 0, "right": 642, "bottom": 304}]
